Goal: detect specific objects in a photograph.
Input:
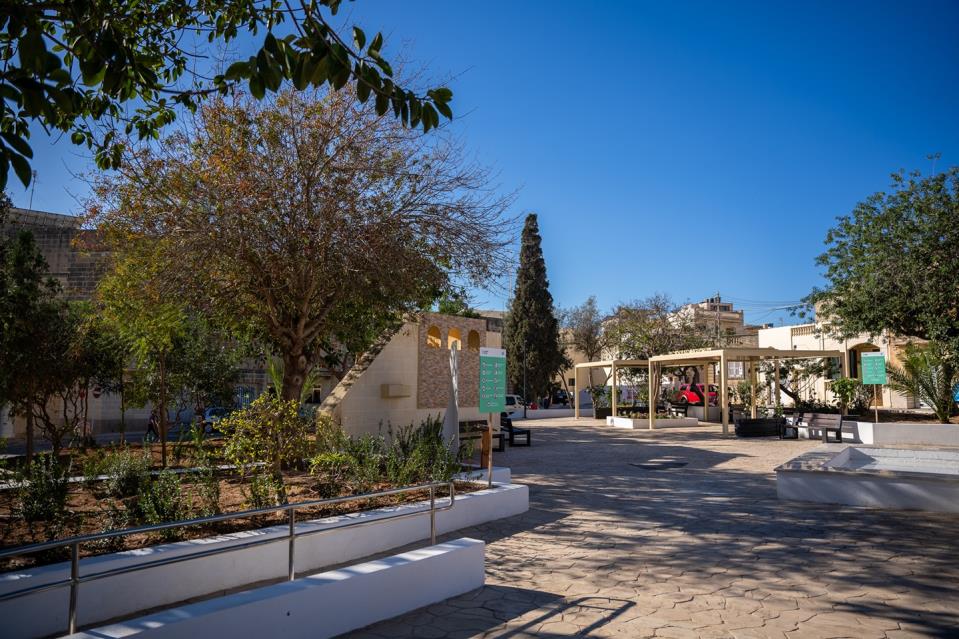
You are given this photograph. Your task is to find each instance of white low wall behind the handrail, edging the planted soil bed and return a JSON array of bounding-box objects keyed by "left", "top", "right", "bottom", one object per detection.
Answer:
[{"left": 0, "top": 484, "right": 529, "bottom": 638}]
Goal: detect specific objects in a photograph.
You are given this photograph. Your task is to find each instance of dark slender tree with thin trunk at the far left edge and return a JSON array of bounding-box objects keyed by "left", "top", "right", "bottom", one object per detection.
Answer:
[{"left": 0, "top": 226, "right": 63, "bottom": 460}]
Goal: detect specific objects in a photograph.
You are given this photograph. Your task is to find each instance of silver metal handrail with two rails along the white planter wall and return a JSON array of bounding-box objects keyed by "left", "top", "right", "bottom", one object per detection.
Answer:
[{"left": 0, "top": 481, "right": 456, "bottom": 634}]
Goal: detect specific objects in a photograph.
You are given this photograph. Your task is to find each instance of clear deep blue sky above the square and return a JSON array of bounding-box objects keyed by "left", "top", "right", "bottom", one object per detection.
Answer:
[{"left": 11, "top": 0, "right": 959, "bottom": 323}]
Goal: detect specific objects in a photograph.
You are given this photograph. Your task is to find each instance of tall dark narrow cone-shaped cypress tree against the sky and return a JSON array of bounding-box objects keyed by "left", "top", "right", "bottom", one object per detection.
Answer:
[{"left": 504, "top": 213, "right": 569, "bottom": 399}]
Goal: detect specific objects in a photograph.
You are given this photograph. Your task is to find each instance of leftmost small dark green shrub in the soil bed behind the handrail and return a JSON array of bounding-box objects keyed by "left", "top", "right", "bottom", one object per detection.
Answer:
[{"left": 17, "top": 455, "right": 70, "bottom": 536}]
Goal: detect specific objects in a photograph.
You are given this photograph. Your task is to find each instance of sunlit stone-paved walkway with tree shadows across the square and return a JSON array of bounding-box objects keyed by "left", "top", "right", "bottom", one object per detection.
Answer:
[{"left": 352, "top": 419, "right": 959, "bottom": 639}]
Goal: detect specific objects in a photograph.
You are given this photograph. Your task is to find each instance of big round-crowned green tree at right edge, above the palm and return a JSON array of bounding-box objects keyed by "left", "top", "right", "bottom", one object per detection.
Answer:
[{"left": 807, "top": 167, "right": 959, "bottom": 366}]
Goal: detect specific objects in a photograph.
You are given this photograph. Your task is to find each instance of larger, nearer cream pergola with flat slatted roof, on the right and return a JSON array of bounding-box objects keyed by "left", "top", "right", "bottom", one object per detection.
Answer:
[{"left": 648, "top": 346, "right": 846, "bottom": 434}]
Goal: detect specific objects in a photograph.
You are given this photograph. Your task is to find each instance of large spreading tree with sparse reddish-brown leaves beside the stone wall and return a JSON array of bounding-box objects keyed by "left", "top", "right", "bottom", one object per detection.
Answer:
[{"left": 91, "top": 90, "right": 511, "bottom": 399}]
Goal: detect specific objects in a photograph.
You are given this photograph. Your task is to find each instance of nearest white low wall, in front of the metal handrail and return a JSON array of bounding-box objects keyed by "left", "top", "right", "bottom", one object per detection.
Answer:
[{"left": 74, "top": 538, "right": 485, "bottom": 639}]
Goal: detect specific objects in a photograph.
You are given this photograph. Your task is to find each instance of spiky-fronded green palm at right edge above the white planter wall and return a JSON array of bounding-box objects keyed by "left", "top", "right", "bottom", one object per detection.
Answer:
[{"left": 887, "top": 343, "right": 959, "bottom": 424}]
